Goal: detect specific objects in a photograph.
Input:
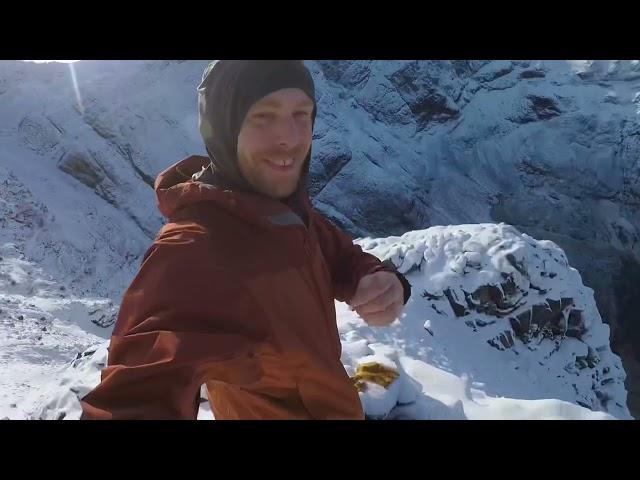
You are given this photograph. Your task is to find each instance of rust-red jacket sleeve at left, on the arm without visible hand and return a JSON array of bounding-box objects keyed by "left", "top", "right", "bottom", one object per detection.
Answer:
[{"left": 81, "top": 223, "right": 261, "bottom": 420}]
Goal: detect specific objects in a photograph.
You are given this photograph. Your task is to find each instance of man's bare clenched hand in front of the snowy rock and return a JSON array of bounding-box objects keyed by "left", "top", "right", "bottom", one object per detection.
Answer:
[{"left": 349, "top": 272, "right": 404, "bottom": 327}]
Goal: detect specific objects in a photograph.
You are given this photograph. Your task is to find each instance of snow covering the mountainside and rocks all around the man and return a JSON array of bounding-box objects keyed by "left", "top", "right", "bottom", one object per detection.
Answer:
[{"left": 0, "top": 61, "right": 640, "bottom": 418}]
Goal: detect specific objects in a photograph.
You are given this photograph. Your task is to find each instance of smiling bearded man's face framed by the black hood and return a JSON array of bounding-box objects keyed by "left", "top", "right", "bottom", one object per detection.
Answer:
[{"left": 238, "top": 88, "right": 314, "bottom": 199}]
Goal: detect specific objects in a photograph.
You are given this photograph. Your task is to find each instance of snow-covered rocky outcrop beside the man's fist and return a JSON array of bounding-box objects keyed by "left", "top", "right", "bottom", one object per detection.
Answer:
[{"left": 340, "top": 224, "right": 630, "bottom": 418}]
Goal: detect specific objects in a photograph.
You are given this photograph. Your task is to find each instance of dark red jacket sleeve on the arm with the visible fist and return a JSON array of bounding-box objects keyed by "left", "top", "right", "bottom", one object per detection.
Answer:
[{"left": 313, "top": 210, "right": 411, "bottom": 304}]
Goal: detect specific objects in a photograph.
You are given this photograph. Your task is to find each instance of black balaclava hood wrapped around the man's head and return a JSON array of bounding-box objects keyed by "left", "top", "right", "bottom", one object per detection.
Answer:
[{"left": 198, "top": 60, "right": 316, "bottom": 223}]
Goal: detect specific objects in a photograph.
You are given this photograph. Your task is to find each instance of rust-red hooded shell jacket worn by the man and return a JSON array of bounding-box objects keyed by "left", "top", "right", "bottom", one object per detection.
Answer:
[{"left": 82, "top": 156, "right": 400, "bottom": 419}]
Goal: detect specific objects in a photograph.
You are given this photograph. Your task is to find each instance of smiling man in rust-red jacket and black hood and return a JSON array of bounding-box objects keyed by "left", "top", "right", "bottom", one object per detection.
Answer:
[{"left": 82, "top": 60, "right": 410, "bottom": 419}]
